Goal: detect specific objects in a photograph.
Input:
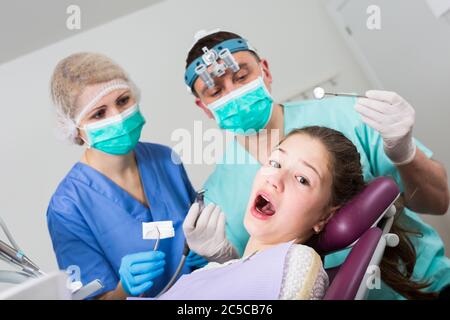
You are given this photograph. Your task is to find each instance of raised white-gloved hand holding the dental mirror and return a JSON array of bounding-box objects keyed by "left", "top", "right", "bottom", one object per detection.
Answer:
[{"left": 355, "top": 90, "right": 416, "bottom": 165}]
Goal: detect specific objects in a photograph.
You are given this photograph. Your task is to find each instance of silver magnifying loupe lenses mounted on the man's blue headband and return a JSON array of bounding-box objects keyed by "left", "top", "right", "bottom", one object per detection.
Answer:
[{"left": 195, "top": 47, "right": 240, "bottom": 89}]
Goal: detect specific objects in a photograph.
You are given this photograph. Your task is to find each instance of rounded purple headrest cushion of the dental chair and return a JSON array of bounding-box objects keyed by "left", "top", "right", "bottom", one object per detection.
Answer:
[{"left": 311, "top": 177, "right": 400, "bottom": 254}]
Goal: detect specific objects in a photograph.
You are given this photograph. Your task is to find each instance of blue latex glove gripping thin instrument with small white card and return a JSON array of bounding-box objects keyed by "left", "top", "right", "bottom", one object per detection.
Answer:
[{"left": 119, "top": 251, "right": 166, "bottom": 296}]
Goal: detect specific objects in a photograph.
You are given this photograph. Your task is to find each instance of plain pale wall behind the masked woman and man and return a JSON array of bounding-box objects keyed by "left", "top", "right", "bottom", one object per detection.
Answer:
[{"left": 0, "top": 0, "right": 442, "bottom": 278}]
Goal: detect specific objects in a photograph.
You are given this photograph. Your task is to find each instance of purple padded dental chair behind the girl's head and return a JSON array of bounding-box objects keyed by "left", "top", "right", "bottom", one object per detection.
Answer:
[{"left": 310, "top": 177, "right": 400, "bottom": 300}]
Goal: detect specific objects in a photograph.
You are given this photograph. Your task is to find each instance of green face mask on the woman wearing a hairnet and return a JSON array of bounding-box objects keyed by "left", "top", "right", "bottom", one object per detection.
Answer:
[{"left": 81, "top": 104, "right": 145, "bottom": 155}]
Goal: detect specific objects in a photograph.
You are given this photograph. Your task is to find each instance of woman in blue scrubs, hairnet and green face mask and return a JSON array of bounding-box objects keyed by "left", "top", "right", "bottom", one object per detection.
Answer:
[{"left": 47, "top": 53, "right": 206, "bottom": 299}]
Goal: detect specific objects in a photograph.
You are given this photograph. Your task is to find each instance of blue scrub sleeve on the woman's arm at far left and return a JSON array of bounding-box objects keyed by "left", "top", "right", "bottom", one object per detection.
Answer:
[{"left": 47, "top": 208, "right": 118, "bottom": 296}]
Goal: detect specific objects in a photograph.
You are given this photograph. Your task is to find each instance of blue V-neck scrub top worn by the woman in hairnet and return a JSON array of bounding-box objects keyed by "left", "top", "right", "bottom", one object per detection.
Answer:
[{"left": 47, "top": 143, "right": 195, "bottom": 296}]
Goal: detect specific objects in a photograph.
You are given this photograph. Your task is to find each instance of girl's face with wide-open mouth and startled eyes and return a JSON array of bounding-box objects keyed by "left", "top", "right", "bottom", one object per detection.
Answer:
[{"left": 244, "top": 134, "right": 333, "bottom": 245}]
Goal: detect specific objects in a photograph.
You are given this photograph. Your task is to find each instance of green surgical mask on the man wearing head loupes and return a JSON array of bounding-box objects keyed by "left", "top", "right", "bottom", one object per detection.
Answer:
[{"left": 208, "top": 77, "right": 273, "bottom": 135}]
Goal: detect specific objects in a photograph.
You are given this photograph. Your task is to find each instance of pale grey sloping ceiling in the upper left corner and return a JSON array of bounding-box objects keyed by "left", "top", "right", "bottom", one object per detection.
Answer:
[{"left": 0, "top": 0, "right": 163, "bottom": 64}]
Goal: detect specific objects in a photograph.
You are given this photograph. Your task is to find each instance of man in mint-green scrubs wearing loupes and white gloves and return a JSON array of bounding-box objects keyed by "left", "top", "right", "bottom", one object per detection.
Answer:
[{"left": 184, "top": 30, "right": 450, "bottom": 299}]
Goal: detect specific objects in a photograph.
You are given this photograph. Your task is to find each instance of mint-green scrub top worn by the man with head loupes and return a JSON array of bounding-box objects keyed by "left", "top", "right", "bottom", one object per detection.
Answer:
[{"left": 204, "top": 97, "right": 450, "bottom": 299}]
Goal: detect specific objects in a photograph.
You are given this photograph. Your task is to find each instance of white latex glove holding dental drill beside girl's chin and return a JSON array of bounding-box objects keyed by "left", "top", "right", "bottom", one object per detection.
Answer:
[{"left": 183, "top": 203, "right": 239, "bottom": 263}]
